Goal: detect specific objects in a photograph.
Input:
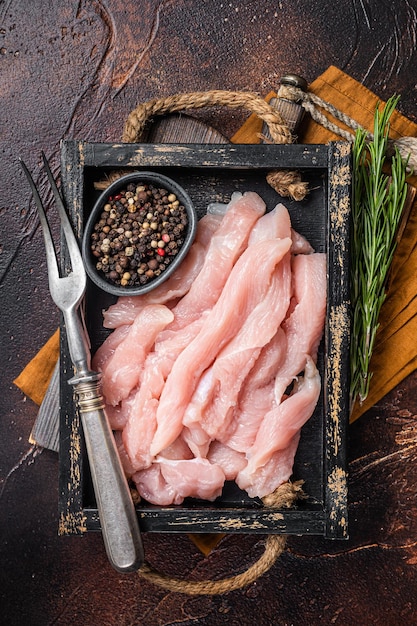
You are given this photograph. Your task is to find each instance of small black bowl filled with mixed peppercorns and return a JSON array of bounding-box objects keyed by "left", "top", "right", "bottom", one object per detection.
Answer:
[{"left": 82, "top": 172, "right": 197, "bottom": 296}]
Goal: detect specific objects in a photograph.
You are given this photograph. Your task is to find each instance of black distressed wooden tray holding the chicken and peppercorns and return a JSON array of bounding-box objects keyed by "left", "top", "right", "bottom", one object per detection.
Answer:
[{"left": 59, "top": 141, "right": 351, "bottom": 539}]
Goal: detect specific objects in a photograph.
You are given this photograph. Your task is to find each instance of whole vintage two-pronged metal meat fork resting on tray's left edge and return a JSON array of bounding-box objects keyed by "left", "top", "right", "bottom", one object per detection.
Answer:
[{"left": 20, "top": 153, "right": 144, "bottom": 572}]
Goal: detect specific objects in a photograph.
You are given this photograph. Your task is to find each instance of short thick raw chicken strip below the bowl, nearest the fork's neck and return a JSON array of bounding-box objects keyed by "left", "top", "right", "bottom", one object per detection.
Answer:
[{"left": 102, "top": 304, "right": 174, "bottom": 406}]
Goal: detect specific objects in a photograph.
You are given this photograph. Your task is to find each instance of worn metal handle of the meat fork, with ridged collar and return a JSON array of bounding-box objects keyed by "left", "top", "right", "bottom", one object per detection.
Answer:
[{"left": 68, "top": 372, "right": 144, "bottom": 572}]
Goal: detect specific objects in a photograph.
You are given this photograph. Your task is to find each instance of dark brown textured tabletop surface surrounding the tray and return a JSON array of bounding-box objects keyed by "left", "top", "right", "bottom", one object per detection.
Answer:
[{"left": 0, "top": 0, "right": 417, "bottom": 626}]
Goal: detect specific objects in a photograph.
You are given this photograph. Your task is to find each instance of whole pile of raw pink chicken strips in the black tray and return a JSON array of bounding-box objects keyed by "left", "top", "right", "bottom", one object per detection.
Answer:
[{"left": 94, "top": 192, "right": 327, "bottom": 506}]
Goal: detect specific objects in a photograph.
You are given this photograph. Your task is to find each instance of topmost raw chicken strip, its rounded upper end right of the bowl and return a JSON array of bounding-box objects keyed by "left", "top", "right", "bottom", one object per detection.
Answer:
[{"left": 165, "top": 191, "right": 266, "bottom": 329}]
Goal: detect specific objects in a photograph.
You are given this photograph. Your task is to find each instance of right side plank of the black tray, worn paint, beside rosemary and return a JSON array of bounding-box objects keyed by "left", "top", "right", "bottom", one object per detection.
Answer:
[{"left": 325, "top": 141, "right": 351, "bottom": 539}]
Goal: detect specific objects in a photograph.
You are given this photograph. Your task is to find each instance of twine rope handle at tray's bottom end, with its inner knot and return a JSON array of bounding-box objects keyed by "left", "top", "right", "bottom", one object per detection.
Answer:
[{"left": 138, "top": 481, "right": 305, "bottom": 596}]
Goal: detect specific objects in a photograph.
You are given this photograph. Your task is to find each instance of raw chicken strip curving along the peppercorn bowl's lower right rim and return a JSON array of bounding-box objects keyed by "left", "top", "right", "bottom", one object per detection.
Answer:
[{"left": 103, "top": 215, "right": 221, "bottom": 328}]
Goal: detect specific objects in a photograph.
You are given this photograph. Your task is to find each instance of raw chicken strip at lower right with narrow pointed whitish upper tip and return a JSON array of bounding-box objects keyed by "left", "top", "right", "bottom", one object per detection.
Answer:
[{"left": 236, "top": 356, "right": 321, "bottom": 497}]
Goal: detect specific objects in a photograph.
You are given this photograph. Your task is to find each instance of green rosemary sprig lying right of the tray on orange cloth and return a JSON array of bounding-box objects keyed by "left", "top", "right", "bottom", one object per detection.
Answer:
[{"left": 350, "top": 96, "right": 407, "bottom": 408}]
